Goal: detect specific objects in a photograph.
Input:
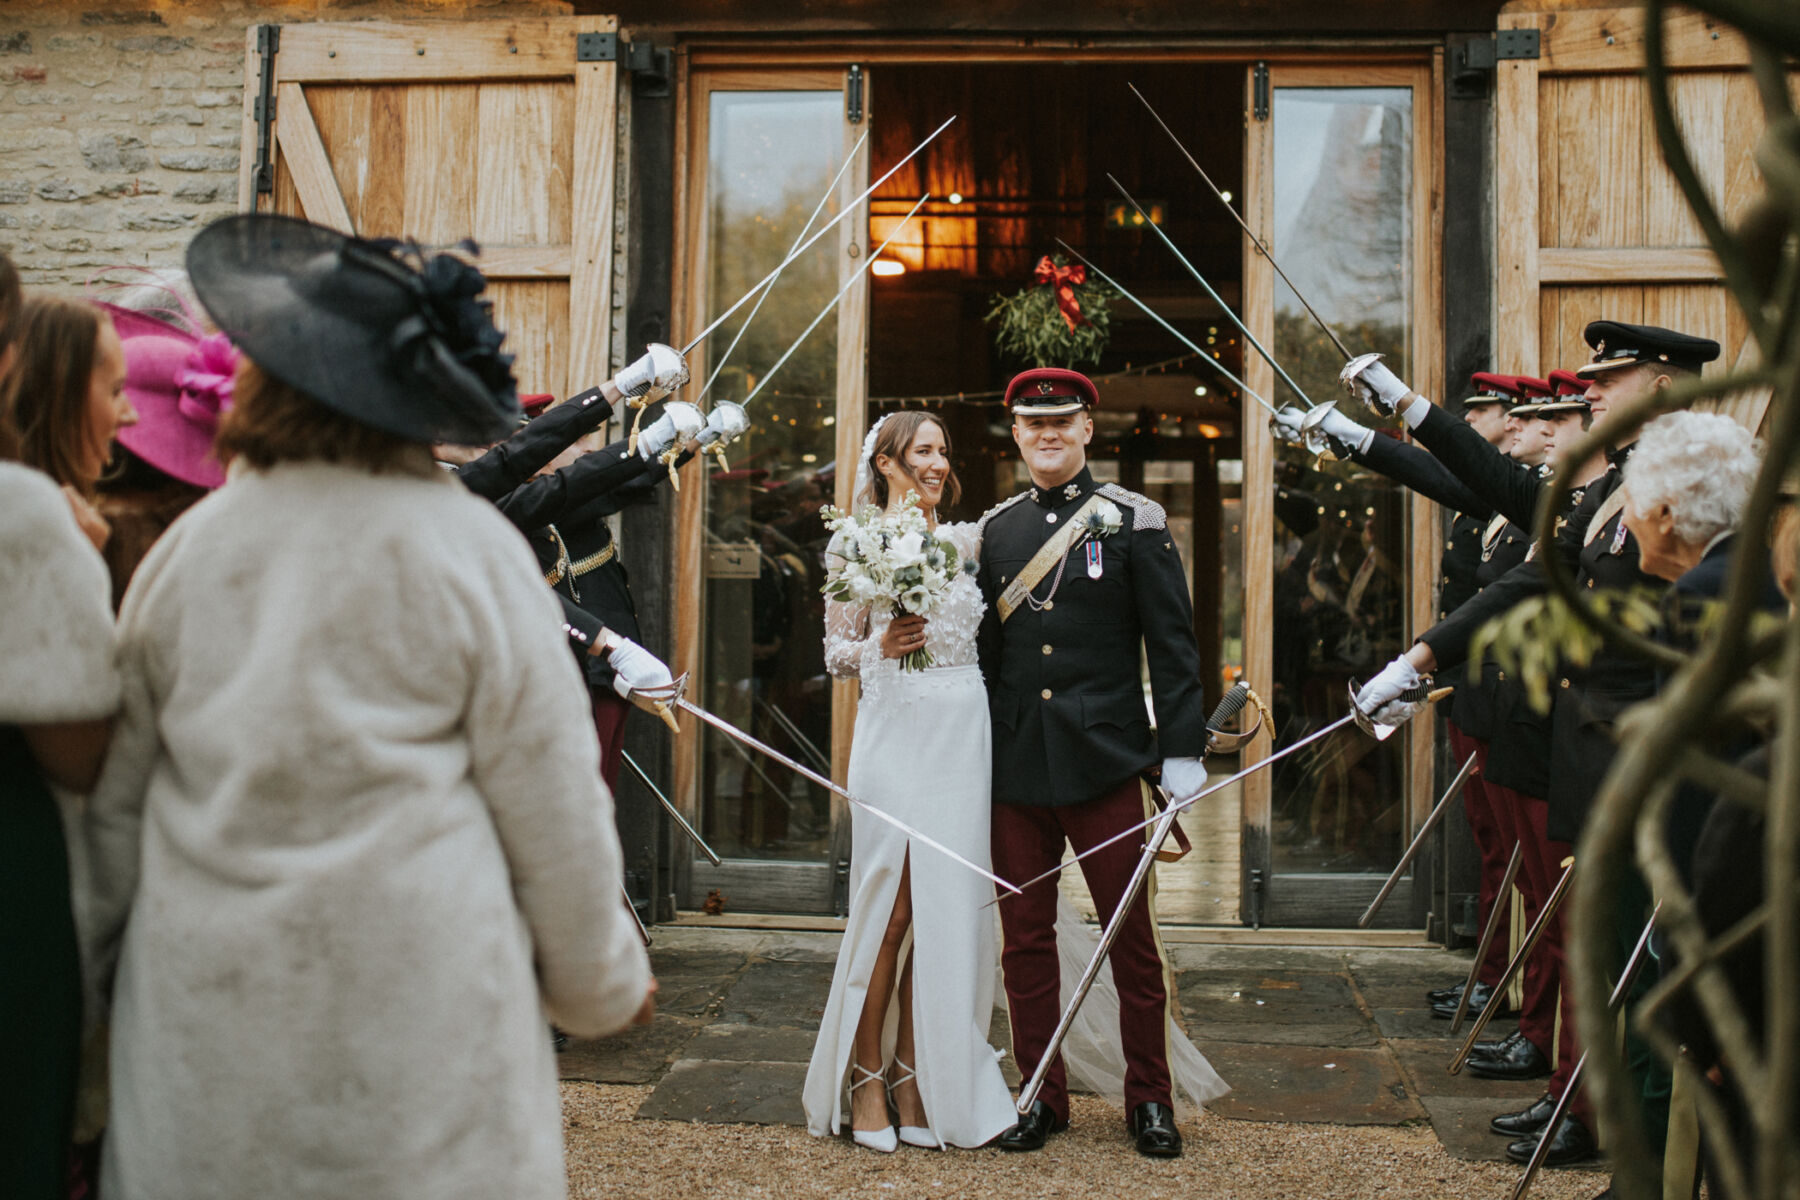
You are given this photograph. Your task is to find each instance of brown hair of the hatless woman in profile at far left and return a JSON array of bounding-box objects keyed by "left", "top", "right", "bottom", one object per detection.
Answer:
[{"left": 0, "top": 295, "right": 106, "bottom": 497}]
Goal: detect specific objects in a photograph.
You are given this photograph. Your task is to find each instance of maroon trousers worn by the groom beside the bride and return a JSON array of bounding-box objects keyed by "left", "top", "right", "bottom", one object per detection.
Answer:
[{"left": 994, "top": 779, "right": 1172, "bottom": 1121}]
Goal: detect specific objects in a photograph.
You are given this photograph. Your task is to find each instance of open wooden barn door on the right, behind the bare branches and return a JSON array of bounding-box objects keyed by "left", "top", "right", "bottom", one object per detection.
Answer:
[{"left": 1494, "top": 7, "right": 1768, "bottom": 428}]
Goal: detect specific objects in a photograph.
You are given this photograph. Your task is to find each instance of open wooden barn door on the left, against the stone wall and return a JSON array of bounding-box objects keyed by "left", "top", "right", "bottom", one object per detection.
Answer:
[{"left": 239, "top": 16, "right": 623, "bottom": 396}]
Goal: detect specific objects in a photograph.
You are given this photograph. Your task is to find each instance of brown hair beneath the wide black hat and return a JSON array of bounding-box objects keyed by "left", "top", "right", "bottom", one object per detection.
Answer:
[{"left": 212, "top": 354, "right": 432, "bottom": 475}]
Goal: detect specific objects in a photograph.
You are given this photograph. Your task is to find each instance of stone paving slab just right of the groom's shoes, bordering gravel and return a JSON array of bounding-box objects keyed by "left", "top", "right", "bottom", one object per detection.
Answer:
[{"left": 1199, "top": 1042, "right": 1426, "bottom": 1124}]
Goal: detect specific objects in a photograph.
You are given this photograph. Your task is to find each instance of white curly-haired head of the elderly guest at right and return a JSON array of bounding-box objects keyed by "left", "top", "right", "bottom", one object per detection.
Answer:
[{"left": 1622, "top": 412, "right": 1762, "bottom": 596}]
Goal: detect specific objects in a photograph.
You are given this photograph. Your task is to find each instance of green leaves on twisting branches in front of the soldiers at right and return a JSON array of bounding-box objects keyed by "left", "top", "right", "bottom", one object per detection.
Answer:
[{"left": 1469, "top": 588, "right": 1663, "bottom": 712}]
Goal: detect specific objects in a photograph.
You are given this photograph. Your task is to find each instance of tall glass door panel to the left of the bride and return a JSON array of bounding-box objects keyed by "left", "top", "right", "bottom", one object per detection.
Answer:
[{"left": 684, "top": 74, "right": 860, "bottom": 912}]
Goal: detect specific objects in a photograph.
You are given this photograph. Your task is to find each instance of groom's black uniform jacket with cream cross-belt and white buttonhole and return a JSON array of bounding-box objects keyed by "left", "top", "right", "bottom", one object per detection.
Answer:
[{"left": 977, "top": 470, "right": 1206, "bottom": 806}]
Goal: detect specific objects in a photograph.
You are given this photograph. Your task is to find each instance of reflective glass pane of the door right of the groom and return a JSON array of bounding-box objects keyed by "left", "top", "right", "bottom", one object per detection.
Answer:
[{"left": 1271, "top": 88, "right": 1413, "bottom": 871}]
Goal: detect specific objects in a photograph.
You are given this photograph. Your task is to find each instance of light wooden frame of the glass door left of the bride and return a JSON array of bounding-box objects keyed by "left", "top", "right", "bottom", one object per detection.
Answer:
[{"left": 670, "top": 56, "right": 873, "bottom": 901}]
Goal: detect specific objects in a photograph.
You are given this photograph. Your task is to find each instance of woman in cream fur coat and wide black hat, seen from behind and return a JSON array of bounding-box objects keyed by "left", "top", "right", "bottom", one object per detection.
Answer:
[{"left": 86, "top": 214, "right": 652, "bottom": 1200}]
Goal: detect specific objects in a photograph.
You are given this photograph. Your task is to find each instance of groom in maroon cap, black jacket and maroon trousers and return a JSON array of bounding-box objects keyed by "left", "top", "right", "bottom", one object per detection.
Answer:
[{"left": 979, "top": 367, "right": 1206, "bottom": 1159}]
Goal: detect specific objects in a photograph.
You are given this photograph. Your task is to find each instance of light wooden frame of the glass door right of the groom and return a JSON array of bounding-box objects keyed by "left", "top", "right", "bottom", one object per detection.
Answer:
[{"left": 1238, "top": 49, "right": 1447, "bottom": 925}]
